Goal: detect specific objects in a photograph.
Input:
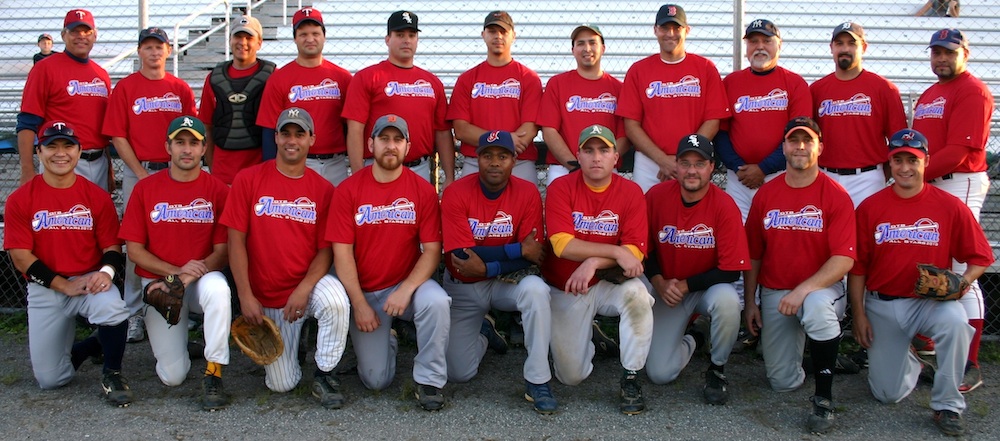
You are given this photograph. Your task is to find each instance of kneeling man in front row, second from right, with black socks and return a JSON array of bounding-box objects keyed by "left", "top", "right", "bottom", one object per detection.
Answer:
[{"left": 743, "top": 116, "right": 856, "bottom": 433}]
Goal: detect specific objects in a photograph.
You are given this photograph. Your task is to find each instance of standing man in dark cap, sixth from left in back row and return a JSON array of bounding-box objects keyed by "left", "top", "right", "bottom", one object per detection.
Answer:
[{"left": 448, "top": 11, "right": 542, "bottom": 184}]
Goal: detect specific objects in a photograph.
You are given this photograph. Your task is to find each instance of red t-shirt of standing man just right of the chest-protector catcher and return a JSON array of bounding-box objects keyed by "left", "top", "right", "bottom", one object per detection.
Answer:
[{"left": 257, "top": 60, "right": 351, "bottom": 155}]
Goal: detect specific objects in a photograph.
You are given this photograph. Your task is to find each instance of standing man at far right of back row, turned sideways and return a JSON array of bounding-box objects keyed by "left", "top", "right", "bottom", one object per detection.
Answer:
[{"left": 913, "top": 29, "right": 993, "bottom": 392}]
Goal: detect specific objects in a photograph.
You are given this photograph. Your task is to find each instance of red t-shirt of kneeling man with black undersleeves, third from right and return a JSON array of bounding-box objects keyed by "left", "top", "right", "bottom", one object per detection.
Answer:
[{"left": 646, "top": 180, "right": 750, "bottom": 280}]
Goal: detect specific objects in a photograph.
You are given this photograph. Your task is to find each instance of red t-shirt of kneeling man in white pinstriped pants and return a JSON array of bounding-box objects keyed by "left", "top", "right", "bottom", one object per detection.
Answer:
[{"left": 221, "top": 160, "right": 334, "bottom": 308}]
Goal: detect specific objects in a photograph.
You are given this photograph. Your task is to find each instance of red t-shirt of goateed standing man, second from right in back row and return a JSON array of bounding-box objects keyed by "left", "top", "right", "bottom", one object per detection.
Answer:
[{"left": 809, "top": 70, "right": 906, "bottom": 168}]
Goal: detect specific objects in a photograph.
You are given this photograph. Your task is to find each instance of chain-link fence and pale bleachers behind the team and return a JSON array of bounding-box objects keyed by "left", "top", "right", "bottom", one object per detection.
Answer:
[{"left": 0, "top": 0, "right": 1000, "bottom": 336}]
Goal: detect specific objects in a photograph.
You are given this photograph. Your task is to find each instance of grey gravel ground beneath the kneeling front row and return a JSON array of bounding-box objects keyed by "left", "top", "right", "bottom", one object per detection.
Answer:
[{"left": 0, "top": 328, "right": 1000, "bottom": 441}]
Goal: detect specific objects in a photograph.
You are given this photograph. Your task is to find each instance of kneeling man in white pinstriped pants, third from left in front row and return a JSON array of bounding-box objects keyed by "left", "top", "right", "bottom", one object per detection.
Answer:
[{"left": 220, "top": 107, "right": 351, "bottom": 409}]
